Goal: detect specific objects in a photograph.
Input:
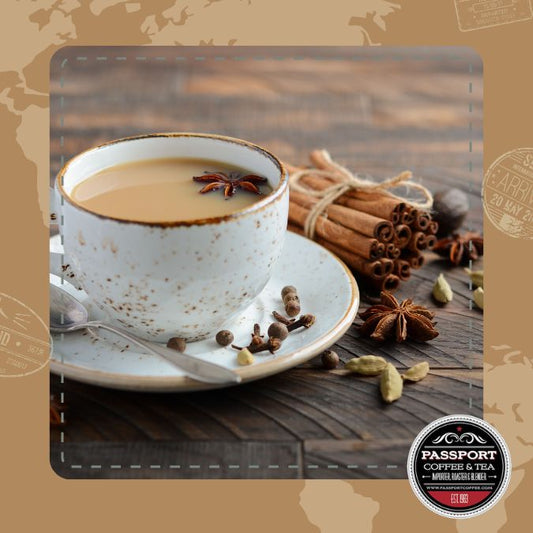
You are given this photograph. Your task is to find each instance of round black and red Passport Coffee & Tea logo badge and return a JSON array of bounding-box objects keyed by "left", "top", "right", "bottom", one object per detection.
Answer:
[{"left": 407, "top": 415, "right": 511, "bottom": 518}]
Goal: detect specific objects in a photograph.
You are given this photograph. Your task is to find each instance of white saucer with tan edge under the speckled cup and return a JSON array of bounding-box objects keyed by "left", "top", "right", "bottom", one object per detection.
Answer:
[{"left": 50, "top": 232, "right": 359, "bottom": 392}]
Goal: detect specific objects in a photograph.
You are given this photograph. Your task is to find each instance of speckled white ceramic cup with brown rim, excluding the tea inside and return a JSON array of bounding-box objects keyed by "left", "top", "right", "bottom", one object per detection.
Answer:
[{"left": 50, "top": 133, "right": 289, "bottom": 342}]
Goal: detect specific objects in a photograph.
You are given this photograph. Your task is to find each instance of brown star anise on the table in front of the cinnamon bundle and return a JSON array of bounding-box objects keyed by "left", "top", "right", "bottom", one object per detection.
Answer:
[{"left": 359, "top": 291, "right": 439, "bottom": 342}]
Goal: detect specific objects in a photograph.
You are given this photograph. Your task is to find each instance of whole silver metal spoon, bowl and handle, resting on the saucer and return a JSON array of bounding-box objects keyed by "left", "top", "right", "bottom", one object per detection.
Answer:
[{"left": 50, "top": 283, "right": 241, "bottom": 384}]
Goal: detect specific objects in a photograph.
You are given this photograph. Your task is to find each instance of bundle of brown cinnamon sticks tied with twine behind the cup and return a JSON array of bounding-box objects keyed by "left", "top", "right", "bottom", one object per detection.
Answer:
[{"left": 286, "top": 152, "right": 438, "bottom": 292}]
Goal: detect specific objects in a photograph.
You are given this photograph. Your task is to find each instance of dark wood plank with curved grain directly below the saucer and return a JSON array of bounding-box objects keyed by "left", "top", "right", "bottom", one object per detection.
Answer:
[{"left": 52, "top": 366, "right": 482, "bottom": 443}]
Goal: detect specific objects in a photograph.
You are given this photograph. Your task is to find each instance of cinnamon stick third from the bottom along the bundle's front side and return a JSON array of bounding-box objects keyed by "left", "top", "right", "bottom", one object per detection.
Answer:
[{"left": 290, "top": 191, "right": 394, "bottom": 242}]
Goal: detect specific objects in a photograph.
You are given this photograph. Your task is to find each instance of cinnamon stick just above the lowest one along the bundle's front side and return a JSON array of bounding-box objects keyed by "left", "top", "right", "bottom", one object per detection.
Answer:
[{"left": 289, "top": 202, "right": 385, "bottom": 260}]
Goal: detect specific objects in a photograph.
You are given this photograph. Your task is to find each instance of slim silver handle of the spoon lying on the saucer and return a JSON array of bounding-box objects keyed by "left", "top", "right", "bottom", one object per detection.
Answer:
[{"left": 85, "top": 321, "right": 241, "bottom": 384}]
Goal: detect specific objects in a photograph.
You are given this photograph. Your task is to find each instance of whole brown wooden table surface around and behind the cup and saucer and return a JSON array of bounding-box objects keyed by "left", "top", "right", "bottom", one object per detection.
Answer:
[{"left": 51, "top": 47, "right": 483, "bottom": 478}]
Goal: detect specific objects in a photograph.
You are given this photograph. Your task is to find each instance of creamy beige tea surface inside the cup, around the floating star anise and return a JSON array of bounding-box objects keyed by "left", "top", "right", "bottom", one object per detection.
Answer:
[{"left": 72, "top": 158, "right": 272, "bottom": 222}]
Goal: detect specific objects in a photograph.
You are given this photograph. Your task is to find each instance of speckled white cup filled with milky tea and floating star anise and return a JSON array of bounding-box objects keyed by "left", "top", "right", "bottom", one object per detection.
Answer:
[{"left": 50, "top": 133, "right": 289, "bottom": 342}]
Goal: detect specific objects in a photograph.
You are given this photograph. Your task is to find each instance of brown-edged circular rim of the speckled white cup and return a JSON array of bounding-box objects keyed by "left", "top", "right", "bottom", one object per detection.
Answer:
[{"left": 55, "top": 132, "right": 288, "bottom": 228}]
